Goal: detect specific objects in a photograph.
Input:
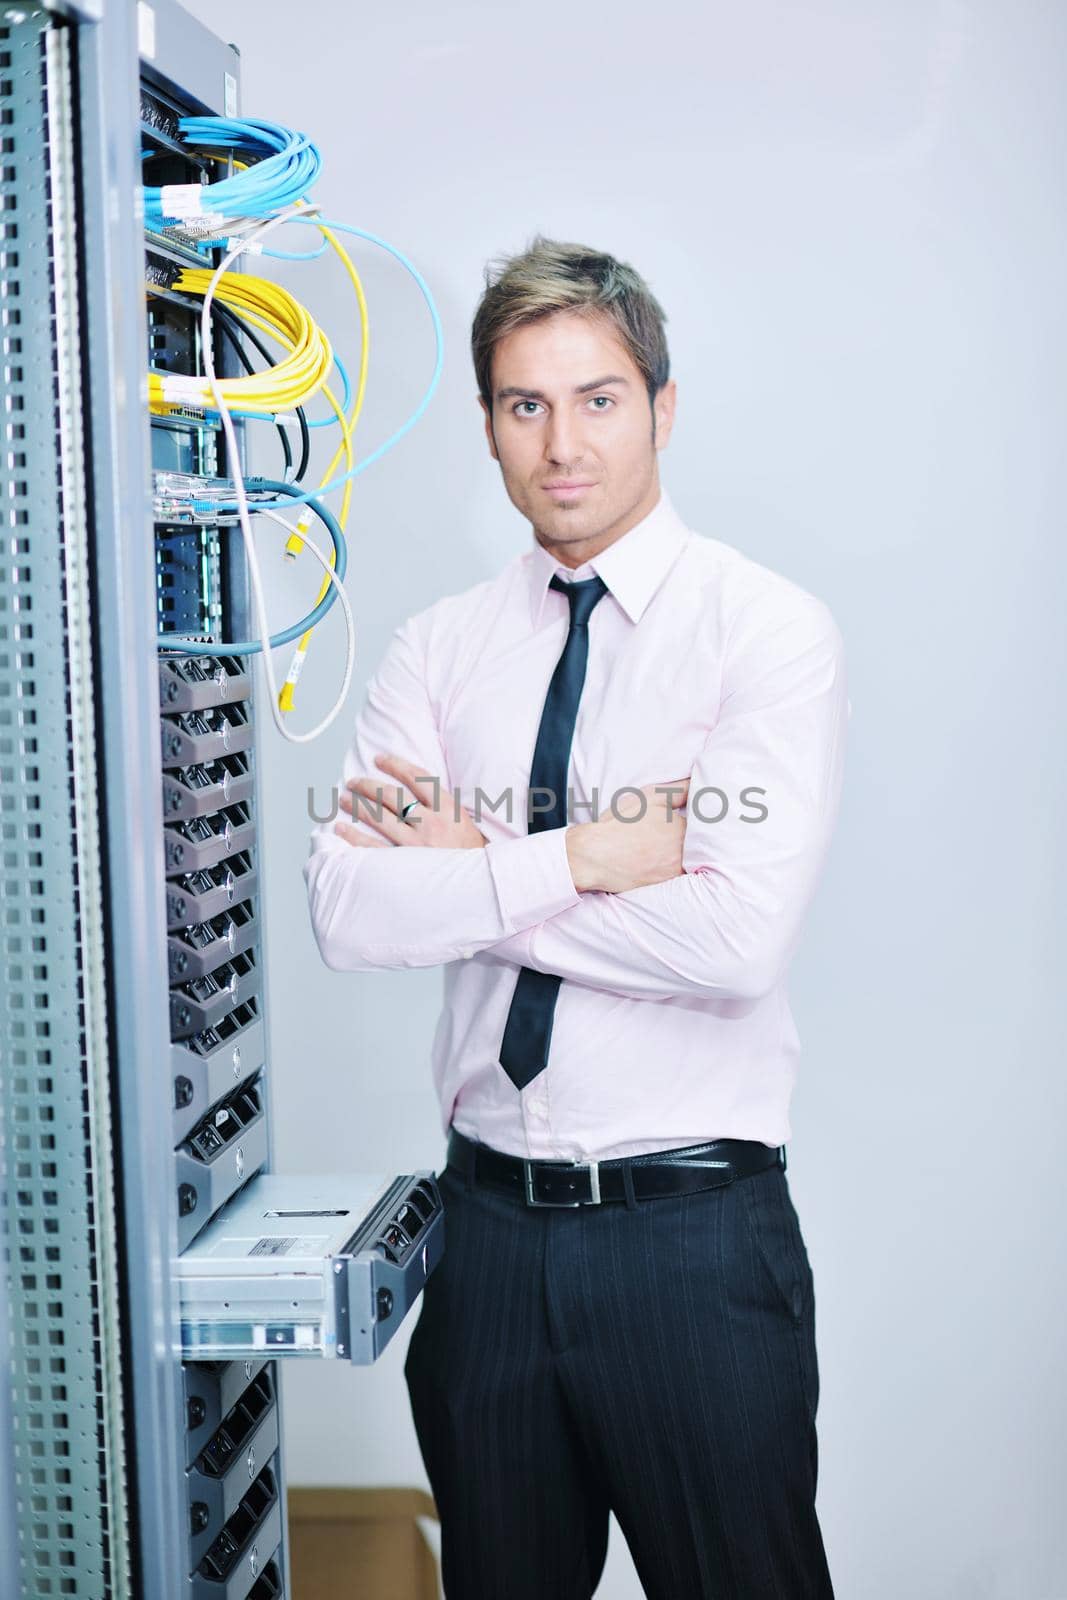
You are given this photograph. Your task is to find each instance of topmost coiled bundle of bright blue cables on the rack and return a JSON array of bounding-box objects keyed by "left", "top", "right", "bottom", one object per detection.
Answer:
[{"left": 144, "top": 117, "right": 322, "bottom": 235}]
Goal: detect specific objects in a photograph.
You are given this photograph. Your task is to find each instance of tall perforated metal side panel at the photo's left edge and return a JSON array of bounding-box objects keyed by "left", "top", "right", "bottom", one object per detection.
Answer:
[{"left": 0, "top": 8, "right": 130, "bottom": 1600}]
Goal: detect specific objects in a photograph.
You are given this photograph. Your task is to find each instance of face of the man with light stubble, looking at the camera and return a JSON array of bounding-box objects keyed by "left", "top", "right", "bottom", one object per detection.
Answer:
[{"left": 480, "top": 312, "right": 675, "bottom": 566}]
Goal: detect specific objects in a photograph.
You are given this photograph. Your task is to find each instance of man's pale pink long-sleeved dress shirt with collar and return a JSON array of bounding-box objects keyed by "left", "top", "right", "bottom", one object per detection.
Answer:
[{"left": 304, "top": 490, "right": 851, "bottom": 1160}]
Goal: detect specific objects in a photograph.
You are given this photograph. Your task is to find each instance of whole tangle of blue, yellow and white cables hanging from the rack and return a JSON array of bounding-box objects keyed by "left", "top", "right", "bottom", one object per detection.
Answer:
[{"left": 144, "top": 117, "right": 443, "bottom": 744}]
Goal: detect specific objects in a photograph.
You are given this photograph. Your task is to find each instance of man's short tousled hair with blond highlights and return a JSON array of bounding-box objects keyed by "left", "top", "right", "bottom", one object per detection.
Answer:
[{"left": 470, "top": 234, "right": 670, "bottom": 416}]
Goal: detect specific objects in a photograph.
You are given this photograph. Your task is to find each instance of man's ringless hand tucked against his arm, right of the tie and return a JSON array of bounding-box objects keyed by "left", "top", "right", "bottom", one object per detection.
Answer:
[{"left": 566, "top": 778, "right": 689, "bottom": 894}]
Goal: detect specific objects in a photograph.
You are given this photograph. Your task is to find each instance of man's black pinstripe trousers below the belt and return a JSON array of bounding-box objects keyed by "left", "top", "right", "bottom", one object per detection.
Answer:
[{"left": 405, "top": 1139, "right": 833, "bottom": 1600}]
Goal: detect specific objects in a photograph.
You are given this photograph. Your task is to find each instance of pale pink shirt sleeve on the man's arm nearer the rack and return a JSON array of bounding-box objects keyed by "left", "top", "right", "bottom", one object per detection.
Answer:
[{"left": 304, "top": 618, "right": 581, "bottom": 971}]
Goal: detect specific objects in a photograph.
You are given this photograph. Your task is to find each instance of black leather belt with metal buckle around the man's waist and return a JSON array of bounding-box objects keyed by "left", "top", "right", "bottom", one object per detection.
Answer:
[{"left": 448, "top": 1128, "right": 785, "bottom": 1206}]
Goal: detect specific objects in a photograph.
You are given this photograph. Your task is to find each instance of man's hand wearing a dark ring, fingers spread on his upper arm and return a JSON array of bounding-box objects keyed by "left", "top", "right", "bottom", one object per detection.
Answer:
[{"left": 333, "top": 755, "right": 486, "bottom": 850}]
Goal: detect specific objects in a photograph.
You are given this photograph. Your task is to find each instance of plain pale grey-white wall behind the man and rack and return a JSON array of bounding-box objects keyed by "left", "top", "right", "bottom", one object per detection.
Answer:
[{"left": 179, "top": 0, "right": 1067, "bottom": 1600}]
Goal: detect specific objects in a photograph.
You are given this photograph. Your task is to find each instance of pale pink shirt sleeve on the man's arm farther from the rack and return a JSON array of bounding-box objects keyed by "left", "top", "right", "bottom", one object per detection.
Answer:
[{"left": 491, "top": 586, "right": 851, "bottom": 1000}]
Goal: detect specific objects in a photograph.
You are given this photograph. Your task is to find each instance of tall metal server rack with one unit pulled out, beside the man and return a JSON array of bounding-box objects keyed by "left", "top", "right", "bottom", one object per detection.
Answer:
[{"left": 0, "top": 0, "right": 442, "bottom": 1600}]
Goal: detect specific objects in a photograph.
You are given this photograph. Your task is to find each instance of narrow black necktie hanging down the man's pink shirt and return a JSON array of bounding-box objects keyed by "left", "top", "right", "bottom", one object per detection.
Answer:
[{"left": 499, "top": 573, "right": 608, "bottom": 1090}]
